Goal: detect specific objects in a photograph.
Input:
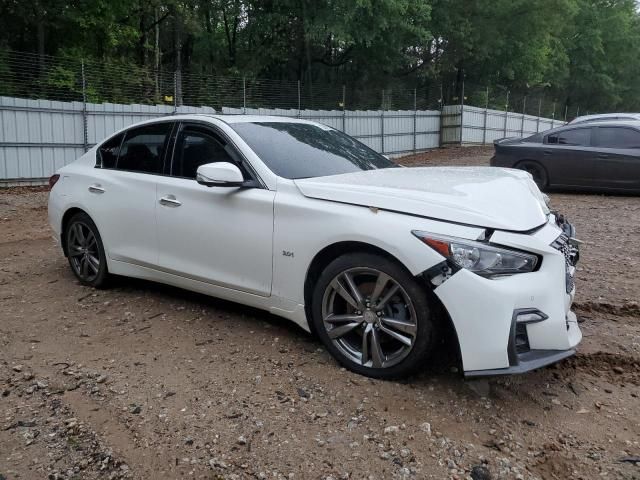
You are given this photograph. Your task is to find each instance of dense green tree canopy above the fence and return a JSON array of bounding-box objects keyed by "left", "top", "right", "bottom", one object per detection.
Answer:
[{"left": 0, "top": 0, "right": 640, "bottom": 111}]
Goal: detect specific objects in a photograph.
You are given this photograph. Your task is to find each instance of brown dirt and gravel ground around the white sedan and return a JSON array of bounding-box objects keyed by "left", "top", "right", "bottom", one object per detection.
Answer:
[{"left": 0, "top": 148, "right": 640, "bottom": 480}]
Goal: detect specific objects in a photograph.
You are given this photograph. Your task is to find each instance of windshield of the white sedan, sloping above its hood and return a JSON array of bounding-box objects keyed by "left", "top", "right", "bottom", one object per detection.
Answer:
[{"left": 231, "top": 122, "right": 397, "bottom": 179}]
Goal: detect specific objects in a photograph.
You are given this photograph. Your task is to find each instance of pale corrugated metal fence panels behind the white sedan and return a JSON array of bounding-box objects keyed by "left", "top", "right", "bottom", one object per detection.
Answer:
[{"left": 0, "top": 97, "right": 561, "bottom": 186}]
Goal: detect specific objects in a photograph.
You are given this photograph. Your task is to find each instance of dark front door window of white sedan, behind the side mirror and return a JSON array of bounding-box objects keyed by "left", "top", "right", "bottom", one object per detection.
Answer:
[{"left": 171, "top": 126, "right": 235, "bottom": 178}]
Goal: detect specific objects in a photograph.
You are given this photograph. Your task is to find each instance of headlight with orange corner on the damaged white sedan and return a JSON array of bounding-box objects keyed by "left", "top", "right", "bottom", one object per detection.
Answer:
[{"left": 411, "top": 230, "right": 538, "bottom": 277}]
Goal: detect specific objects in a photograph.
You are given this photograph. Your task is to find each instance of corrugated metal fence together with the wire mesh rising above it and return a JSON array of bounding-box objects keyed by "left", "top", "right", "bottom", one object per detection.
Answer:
[{"left": 0, "top": 50, "right": 587, "bottom": 184}]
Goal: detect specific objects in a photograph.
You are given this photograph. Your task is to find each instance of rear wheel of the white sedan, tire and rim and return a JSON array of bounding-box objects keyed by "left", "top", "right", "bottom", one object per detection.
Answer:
[{"left": 64, "top": 212, "right": 109, "bottom": 288}]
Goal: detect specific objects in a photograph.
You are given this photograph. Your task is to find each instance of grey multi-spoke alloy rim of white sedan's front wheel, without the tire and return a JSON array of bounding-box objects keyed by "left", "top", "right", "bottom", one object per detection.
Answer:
[{"left": 322, "top": 267, "right": 418, "bottom": 368}]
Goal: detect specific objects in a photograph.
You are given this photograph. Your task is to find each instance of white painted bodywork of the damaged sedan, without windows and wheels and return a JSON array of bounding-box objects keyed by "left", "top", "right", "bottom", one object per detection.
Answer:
[{"left": 49, "top": 115, "right": 581, "bottom": 374}]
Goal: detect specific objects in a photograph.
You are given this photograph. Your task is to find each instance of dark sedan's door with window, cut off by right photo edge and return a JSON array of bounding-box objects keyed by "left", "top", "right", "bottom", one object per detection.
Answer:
[{"left": 595, "top": 125, "right": 640, "bottom": 190}]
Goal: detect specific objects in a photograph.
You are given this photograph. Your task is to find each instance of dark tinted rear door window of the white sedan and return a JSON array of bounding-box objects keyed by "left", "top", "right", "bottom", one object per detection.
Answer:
[{"left": 117, "top": 123, "right": 173, "bottom": 173}]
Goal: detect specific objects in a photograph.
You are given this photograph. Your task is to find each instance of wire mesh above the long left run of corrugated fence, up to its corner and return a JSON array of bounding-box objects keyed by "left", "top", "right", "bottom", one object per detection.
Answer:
[{"left": 0, "top": 50, "right": 456, "bottom": 110}]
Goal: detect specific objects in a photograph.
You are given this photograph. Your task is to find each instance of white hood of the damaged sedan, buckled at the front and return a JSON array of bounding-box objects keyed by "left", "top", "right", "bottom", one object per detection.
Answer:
[{"left": 295, "top": 167, "right": 549, "bottom": 231}]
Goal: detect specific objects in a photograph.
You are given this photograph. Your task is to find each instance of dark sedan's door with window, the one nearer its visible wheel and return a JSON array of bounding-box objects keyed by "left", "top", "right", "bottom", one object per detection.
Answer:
[{"left": 541, "top": 127, "right": 597, "bottom": 187}]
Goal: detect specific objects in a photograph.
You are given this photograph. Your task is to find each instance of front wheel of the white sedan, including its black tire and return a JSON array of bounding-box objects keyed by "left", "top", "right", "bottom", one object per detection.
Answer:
[{"left": 312, "top": 253, "right": 435, "bottom": 379}]
